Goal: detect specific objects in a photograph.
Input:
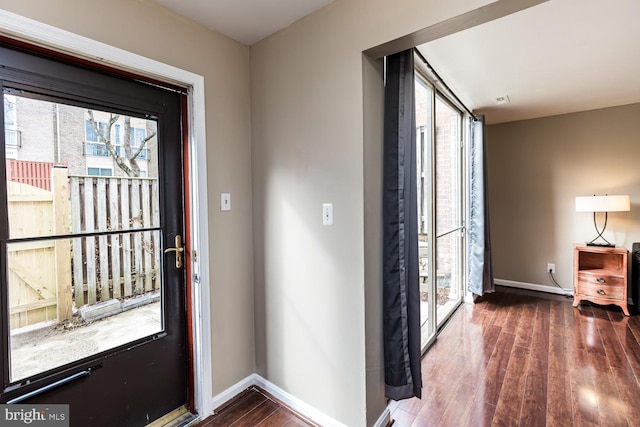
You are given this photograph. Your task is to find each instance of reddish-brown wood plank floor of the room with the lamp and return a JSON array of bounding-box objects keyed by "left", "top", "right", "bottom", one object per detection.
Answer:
[{"left": 389, "top": 288, "right": 640, "bottom": 427}]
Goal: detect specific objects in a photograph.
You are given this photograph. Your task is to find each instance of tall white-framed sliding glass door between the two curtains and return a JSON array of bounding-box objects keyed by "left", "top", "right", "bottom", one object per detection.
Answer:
[{"left": 415, "top": 73, "right": 464, "bottom": 349}]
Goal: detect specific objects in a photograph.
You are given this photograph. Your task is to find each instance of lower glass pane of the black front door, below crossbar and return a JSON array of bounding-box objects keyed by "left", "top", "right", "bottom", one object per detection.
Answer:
[{"left": 7, "top": 232, "right": 163, "bottom": 381}]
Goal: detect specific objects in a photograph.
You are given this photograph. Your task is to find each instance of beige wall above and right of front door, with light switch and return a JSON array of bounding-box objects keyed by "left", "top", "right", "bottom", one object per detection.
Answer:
[{"left": 0, "top": 0, "right": 255, "bottom": 395}]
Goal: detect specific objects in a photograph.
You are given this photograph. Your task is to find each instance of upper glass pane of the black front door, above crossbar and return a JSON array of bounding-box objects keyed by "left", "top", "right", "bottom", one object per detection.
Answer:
[{"left": 4, "top": 94, "right": 158, "bottom": 239}]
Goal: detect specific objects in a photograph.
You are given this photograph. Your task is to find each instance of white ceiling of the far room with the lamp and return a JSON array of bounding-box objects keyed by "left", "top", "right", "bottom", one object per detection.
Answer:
[{"left": 419, "top": 0, "right": 640, "bottom": 123}]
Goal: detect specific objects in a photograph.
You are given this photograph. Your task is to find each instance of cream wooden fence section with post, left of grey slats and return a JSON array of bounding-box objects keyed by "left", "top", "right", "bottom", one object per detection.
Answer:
[{"left": 7, "top": 167, "right": 72, "bottom": 329}]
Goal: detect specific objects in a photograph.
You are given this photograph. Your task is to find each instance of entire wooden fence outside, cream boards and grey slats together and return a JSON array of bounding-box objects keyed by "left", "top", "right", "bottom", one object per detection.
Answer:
[{"left": 7, "top": 167, "right": 160, "bottom": 329}]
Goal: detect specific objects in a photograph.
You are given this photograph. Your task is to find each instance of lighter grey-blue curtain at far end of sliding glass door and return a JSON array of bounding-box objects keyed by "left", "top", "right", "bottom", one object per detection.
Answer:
[{"left": 467, "top": 116, "right": 495, "bottom": 295}]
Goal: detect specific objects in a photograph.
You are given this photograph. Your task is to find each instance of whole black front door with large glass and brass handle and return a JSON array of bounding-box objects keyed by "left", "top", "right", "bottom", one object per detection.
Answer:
[{"left": 0, "top": 42, "right": 189, "bottom": 426}]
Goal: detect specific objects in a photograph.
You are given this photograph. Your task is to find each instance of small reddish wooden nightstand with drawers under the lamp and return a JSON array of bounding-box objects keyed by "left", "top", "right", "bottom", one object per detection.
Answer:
[{"left": 573, "top": 245, "right": 629, "bottom": 316}]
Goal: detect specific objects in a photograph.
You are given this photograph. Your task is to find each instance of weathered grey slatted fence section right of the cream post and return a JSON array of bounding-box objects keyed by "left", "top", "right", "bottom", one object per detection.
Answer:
[{"left": 69, "top": 176, "right": 160, "bottom": 307}]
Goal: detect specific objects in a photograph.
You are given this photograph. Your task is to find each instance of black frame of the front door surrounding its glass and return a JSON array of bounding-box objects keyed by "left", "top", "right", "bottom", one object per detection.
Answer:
[{"left": 0, "top": 42, "right": 189, "bottom": 425}]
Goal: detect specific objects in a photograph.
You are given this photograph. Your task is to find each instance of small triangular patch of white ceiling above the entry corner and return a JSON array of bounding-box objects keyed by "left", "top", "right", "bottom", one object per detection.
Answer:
[{"left": 155, "top": 0, "right": 333, "bottom": 46}]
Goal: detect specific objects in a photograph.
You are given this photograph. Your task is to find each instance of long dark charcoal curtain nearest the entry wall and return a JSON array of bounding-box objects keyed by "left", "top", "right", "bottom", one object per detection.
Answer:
[{"left": 383, "top": 50, "right": 422, "bottom": 400}]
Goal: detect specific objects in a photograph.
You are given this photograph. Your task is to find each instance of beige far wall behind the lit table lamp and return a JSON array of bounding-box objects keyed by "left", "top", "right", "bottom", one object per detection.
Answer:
[{"left": 488, "top": 104, "right": 640, "bottom": 296}]
